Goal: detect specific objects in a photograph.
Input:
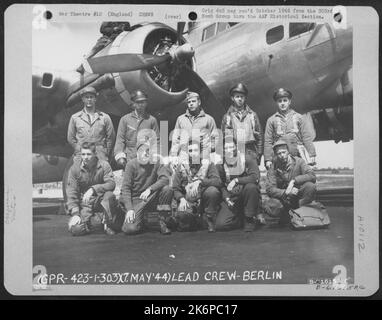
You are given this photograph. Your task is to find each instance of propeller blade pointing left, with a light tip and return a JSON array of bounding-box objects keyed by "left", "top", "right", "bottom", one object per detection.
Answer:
[{"left": 84, "top": 53, "right": 171, "bottom": 74}]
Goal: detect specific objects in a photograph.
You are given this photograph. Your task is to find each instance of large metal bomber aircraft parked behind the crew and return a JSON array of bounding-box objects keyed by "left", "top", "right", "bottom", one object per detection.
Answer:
[{"left": 32, "top": 22, "right": 353, "bottom": 183}]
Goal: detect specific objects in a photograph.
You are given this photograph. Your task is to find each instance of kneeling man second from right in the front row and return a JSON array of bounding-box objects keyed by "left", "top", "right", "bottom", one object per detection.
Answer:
[{"left": 216, "top": 137, "right": 261, "bottom": 232}]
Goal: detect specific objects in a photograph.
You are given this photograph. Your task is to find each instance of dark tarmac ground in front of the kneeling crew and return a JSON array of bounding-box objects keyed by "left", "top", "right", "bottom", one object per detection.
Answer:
[{"left": 33, "top": 199, "right": 354, "bottom": 284}]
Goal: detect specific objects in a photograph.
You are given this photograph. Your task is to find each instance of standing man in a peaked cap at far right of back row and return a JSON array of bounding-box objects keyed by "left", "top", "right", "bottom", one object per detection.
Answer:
[{"left": 264, "top": 88, "right": 316, "bottom": 169}]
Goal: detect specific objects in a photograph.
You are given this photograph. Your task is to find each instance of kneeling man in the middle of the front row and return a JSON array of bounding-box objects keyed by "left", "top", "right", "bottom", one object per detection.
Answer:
[{"left": 173, "top": 140, "right": 221, "bottom": 232}]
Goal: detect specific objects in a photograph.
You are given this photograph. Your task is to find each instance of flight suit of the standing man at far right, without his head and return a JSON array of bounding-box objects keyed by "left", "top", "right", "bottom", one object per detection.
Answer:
[{"left": 264, "top": 109, "right": 316, "bottom": 162}]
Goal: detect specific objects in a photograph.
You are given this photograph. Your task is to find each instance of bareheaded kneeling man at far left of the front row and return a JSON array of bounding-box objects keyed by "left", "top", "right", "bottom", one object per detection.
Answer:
[{"left": 66, "top": 142, "right": 118, "bottom": 236}]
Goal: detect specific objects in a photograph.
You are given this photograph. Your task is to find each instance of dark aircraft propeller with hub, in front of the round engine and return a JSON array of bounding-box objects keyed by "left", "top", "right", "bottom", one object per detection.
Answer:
[{"left": 84, "top": 22, "right": 223, "bottom": 123}]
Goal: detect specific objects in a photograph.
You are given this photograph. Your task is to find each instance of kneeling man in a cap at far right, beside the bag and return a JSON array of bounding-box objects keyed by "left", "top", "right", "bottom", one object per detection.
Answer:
[{"left": 265, "top": 140, "right": 316, "bottom": 223}]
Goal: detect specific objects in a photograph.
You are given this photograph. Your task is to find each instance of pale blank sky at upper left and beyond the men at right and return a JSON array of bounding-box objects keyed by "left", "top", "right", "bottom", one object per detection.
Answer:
[{"left": 32, "top": 23, "right": 354, "bottom": 168}]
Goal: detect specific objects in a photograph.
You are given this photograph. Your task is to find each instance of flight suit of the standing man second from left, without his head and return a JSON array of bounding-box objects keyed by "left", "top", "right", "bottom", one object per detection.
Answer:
[{"left": 114, "top": 111, "right": 160, "bottom": 162}]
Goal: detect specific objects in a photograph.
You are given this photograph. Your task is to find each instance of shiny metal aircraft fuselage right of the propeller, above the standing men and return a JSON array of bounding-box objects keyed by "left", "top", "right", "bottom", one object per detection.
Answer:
[{"left": 195, "top": 23, "right": 352, "bottom": 123}]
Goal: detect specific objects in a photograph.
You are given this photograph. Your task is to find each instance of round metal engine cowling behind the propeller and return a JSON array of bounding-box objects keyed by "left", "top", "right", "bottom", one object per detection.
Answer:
[{"left": 68, "top": 23, "right": 195, "bottom": 120}]
